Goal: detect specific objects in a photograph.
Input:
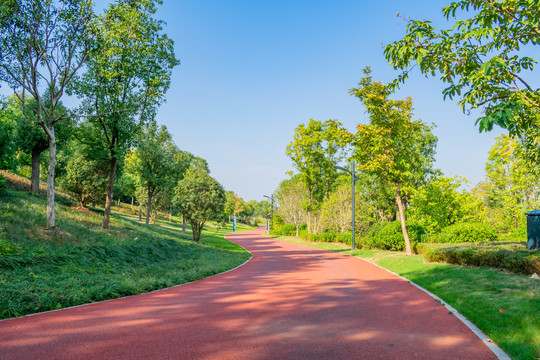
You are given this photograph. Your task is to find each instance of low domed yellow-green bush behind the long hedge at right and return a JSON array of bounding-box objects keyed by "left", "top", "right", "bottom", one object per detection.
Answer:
[{"left": 432, "top": 223, "right": 498, "bottom": 243}]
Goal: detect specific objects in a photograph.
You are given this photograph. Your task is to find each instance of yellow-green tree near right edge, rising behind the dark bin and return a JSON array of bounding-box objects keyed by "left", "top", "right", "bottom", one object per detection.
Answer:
[{"left": 486, "top": 135, "right": 540, "bottom": 228}]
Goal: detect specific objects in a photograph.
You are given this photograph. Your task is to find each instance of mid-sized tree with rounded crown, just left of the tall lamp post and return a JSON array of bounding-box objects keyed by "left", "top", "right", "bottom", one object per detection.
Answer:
[{"left": 285, "top": 119, "right": 350, "bottom": 233}]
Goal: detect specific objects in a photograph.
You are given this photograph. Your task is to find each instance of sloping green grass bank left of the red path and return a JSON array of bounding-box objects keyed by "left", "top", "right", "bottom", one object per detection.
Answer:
[{"left": 0, "top": 190, "right": 252, "bottom": 318}]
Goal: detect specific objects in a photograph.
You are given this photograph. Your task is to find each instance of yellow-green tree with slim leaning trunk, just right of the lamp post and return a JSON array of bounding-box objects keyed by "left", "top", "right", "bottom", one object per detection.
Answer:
[{"left": 349, "top": 67, "right": 437, "bottom": 254}]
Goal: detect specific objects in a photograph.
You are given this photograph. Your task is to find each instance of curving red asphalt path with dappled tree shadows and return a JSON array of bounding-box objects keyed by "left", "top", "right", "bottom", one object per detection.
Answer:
[{"left": 0, "top": 229, "right": 496, "bottom": 360}]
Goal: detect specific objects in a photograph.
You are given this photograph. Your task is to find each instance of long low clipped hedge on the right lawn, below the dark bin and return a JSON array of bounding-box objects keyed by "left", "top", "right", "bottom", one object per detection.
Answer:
[{"left": 417, "top": 242, "right": 540, "bottom": 275}]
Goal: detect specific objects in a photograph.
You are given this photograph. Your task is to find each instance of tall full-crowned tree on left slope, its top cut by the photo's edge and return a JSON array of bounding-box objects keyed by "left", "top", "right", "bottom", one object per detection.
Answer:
[{"left": 73, "top": 0, "right": 179, "bottom": 229}]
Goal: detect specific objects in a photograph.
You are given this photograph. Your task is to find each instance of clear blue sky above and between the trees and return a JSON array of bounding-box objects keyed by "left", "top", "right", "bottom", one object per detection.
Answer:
[{"left": 5, "top": 0, "right": 540, "bottom": 201}]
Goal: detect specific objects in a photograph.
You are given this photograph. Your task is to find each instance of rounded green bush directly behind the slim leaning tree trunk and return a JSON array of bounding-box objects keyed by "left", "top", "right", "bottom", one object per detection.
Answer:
[{"left": 364, "top": 221, "right": 425, "bottom": 251}]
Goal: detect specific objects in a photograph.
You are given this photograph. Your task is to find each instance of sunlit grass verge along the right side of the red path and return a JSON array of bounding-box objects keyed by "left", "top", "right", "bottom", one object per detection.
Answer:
[{"left": 276, "top": 236, "right": 540, "bottom": 360}]
